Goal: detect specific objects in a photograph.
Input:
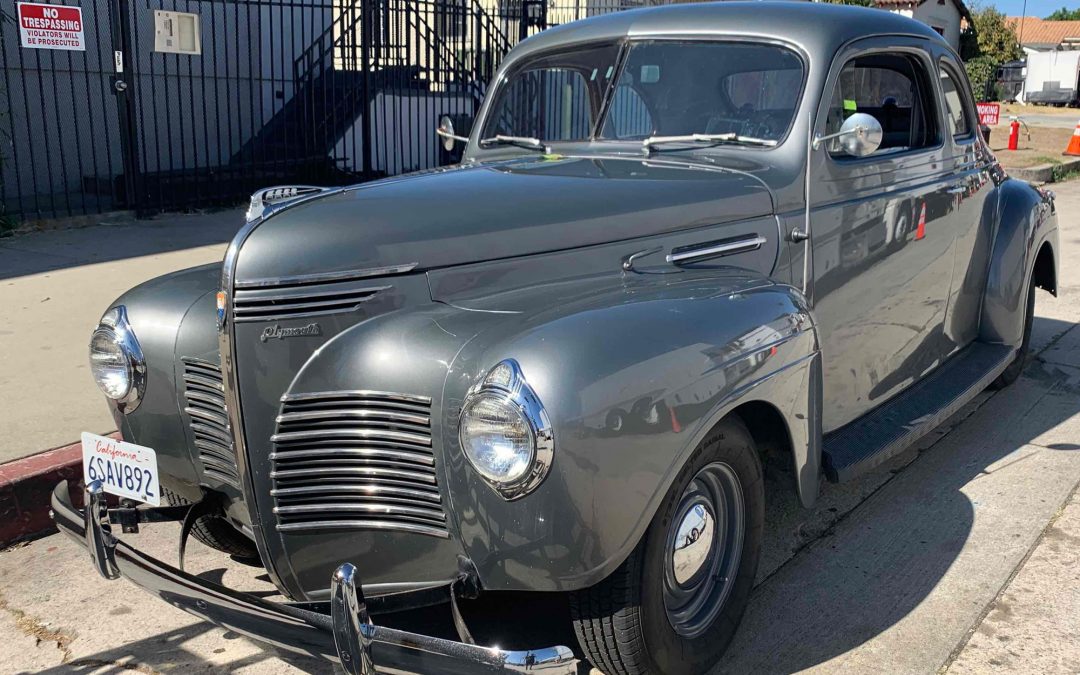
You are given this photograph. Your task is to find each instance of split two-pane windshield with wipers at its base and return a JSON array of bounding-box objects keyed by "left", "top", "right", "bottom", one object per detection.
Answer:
[{"left": 482, "top": 41, "right": 804, "bottom": 145}]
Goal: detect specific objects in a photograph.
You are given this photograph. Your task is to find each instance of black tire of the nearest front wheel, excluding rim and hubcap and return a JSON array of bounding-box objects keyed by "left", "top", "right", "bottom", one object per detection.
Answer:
[{"left": 570, "top": 419, "right": 765, "bottom": 675}]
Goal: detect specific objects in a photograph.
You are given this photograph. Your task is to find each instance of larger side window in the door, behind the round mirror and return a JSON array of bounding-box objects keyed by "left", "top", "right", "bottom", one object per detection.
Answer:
[{"left": 825, "top": 54, "right": 940, "bottom": 157}]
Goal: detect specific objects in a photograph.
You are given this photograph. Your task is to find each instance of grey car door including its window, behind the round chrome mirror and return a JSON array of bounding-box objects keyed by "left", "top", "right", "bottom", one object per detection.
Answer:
[{"left": 807, "top": 37, "right": 954, "bottom": 432}]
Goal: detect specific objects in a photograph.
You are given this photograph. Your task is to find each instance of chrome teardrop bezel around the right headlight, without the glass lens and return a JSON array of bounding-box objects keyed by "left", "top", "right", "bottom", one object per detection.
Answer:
[{"left": 458, "top": 359, "right": 555, "bottom": 501}]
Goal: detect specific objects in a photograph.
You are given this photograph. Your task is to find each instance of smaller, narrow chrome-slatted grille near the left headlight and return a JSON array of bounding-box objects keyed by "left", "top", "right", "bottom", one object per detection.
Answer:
[{"left": 180, "top": 356, "right": 240, "bottom": 490}]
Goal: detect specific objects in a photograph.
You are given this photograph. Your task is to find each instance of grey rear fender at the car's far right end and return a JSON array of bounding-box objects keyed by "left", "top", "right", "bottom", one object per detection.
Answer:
[{"left": 978, "top": 179, "right": 1057, "bottom": 348}]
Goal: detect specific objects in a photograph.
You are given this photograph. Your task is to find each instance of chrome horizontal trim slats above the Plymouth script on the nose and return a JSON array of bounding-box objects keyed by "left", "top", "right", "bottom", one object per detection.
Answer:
[{"left": 232, "top": 279, "right": 390, "bottom": 322}]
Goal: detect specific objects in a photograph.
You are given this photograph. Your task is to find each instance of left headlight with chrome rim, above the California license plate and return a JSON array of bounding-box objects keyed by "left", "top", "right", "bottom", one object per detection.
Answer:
[{"left": 90, "top": 305, "right": 146, "bottom": 414}]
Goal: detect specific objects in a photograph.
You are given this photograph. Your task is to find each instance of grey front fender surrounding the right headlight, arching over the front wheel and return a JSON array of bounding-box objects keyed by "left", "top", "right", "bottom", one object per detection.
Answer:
[{"left": 443, "top": 269, "right": 820, "bottom": 591}]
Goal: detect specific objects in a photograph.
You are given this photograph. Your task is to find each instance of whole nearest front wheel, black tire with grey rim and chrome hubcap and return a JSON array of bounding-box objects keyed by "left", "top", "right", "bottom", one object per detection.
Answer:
[{"left": 570, "top": 419, "right": 765, "bottom": 675}]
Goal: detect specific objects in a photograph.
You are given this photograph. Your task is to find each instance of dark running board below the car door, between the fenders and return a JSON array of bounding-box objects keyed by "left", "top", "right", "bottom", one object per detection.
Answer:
[{"left": 822, "top": 342, "right": 1016, "bottom": 483}]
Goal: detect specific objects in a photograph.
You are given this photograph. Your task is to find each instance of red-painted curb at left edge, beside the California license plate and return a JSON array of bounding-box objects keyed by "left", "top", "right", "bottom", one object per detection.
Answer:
[{"left": 0, "top": 432, "right": 120, "bottom": 546}]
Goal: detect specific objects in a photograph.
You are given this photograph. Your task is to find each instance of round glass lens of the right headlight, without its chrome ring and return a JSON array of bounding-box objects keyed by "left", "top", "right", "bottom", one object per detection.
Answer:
[{"left": 461, "top": 394, "right": 536, "bottom": 483}]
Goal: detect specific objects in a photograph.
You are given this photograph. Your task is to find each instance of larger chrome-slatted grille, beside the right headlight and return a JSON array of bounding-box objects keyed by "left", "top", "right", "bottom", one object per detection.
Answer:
[{"left": 270, "top": 391, "right": 448, "bottom": 537}]
